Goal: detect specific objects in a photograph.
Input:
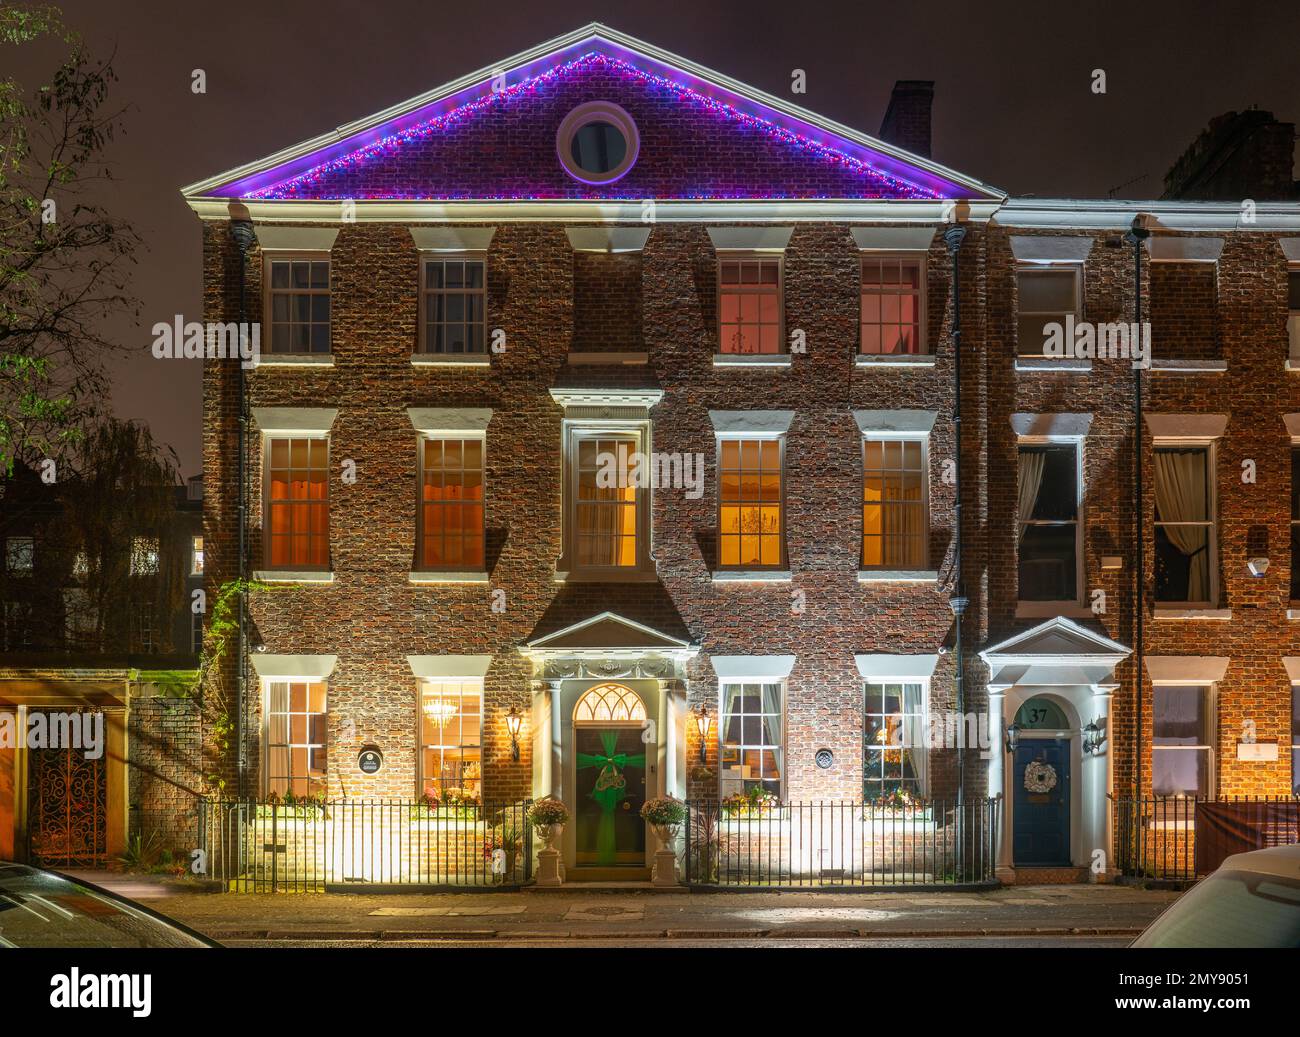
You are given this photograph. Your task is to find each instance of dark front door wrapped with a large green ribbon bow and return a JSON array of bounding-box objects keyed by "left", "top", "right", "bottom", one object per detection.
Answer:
[{"left": 573, "top": 724, "right": 646, "bottom": 868}]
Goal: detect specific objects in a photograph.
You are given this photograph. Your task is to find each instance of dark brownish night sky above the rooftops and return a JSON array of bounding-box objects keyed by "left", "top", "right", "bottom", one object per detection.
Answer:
[{"left": 25, "top": 0, "right": 1300, "bottom": 474}]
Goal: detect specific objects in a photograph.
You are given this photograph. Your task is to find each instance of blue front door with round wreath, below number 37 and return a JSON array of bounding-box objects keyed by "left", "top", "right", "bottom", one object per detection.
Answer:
[{"left": 1013, "top": 738, "right": 1070, "bottom": 864}]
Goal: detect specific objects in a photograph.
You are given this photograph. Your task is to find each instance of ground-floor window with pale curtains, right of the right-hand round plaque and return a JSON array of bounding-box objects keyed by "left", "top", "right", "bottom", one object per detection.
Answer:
[{"left": 862, "top": 682, "right": 930, "bottom": 802}]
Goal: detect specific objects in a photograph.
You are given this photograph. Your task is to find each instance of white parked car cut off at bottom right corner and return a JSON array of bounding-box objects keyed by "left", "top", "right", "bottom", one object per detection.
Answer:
[{"left": 1132, "top": 846, "right": 1300, "bottom": 947}]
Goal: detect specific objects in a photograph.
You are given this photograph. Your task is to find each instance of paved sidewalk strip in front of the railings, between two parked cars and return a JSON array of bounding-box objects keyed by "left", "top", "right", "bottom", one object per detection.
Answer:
[{"left": 106, "top": 876, "right": 1178, "bottom": 941}]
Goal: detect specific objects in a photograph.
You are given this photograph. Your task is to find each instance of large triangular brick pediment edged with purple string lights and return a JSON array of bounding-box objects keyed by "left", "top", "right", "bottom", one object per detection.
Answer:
[{"left": 183, "top": 23, "right": 1002, "bottom": 204}]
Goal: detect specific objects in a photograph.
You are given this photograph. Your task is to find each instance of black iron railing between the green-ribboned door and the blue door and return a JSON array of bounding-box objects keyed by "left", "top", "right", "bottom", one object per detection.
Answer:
[{"left": 683, "top": 799, "right": 998, "bottom": 889}]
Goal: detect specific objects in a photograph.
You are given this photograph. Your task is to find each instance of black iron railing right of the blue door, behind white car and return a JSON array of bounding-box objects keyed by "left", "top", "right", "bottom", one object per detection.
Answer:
[{"left": 1114, "top": 795, "right": 1300, "bottom": 882}]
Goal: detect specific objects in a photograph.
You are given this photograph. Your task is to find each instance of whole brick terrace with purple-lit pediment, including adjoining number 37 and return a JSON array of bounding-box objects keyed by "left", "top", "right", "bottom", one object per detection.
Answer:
[{"left": 185, "top": 26, "right": 1300, "bottom": 880}]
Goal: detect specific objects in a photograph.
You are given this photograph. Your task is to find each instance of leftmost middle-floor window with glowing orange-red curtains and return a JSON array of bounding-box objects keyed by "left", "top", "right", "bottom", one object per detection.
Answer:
[{"left": 264, "top": 438, "right": 329, "bottom": 569}]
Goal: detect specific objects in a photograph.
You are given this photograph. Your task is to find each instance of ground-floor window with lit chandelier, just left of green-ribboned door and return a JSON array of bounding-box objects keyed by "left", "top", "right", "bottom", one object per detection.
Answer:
[{"left": 420, "top": 681, "right": 484, "bottom": 803}]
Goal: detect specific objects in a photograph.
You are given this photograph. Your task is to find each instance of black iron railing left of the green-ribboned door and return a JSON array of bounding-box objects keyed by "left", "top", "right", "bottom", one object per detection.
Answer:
[{"left": 203, "top": 799, "right": 533, "bottom": 893}]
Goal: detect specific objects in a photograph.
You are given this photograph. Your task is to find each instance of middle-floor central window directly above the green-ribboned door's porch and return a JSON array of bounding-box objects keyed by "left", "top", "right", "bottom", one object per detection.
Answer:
[{"left": 573, "top": 435, "right": 641, "bottom": 569}]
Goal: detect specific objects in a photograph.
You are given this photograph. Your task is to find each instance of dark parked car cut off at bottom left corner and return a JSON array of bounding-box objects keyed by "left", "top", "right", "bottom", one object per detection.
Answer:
[{"left": 0, "top": 862, "right": 218, "bottom": 947}]
